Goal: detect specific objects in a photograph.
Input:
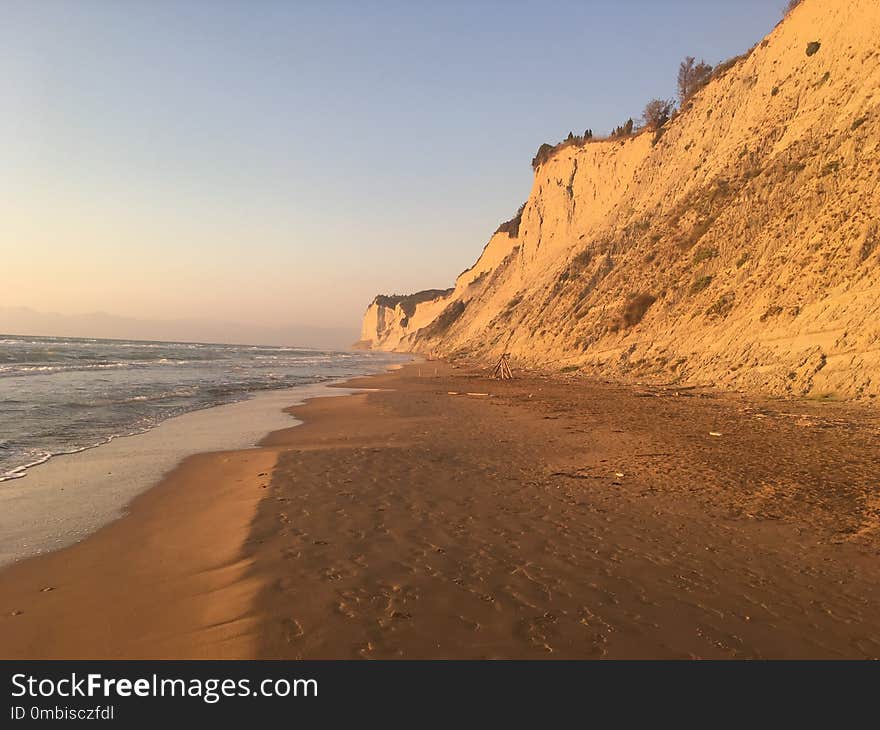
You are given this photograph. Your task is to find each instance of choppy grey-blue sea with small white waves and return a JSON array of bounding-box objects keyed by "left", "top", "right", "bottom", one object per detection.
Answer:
[{"left": 0, "top": 335, "right": 404, "bottom": 482}]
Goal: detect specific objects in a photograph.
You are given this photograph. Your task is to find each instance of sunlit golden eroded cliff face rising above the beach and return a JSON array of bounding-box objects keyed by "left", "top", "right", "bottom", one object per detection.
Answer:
[{"left": 362, "top": 0, "right": 880, "bottom": 398}]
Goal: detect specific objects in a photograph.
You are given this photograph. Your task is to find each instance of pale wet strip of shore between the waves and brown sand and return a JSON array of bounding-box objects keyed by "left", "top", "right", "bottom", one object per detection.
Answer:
[{"left": 0, "top": 379, "right": 372, "bottom": 568}]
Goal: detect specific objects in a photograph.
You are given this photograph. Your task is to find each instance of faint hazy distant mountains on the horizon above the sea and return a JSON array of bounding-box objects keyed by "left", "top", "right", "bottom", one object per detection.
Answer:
[{"left": 0, "top": 306, "right": 357, "bottom": 350}]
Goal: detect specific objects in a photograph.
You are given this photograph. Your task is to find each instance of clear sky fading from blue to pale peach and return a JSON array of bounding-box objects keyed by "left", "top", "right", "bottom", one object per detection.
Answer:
[{"left": 0, "top": 0, "right": 784, "bottom": 336}]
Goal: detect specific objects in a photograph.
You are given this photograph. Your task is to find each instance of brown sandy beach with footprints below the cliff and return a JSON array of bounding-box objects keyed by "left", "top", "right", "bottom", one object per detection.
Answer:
[{"left": 0, "top": 362, "right": 880, "bottom": 658}]
